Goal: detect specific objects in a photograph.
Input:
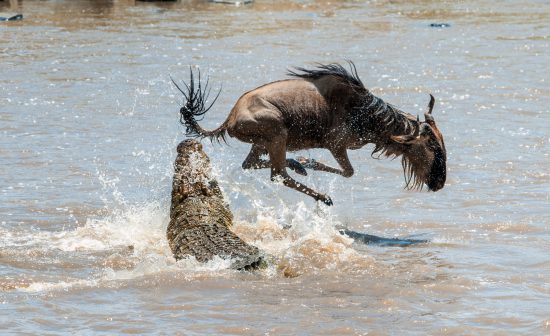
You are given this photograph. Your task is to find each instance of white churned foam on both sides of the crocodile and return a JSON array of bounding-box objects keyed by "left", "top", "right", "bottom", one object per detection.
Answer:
[{"left": 10, "top": 168, "right": 376, "bottom": 292}]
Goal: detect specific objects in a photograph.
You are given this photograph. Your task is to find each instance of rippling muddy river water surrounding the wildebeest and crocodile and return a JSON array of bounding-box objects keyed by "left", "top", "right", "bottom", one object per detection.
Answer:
[{"left": 0, "top": 0, "right": 550, "bottom": 335}]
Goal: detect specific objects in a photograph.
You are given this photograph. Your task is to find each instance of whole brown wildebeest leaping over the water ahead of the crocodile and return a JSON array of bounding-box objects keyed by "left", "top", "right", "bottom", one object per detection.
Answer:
[{"left": 174, "top": 61, "right": 447, "bottom": 205}]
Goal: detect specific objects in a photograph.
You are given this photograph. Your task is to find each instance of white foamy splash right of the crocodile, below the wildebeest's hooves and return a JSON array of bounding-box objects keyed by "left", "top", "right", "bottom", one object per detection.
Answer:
[{"left": 234, "top": 202, "right": 372, "bottom": 276}]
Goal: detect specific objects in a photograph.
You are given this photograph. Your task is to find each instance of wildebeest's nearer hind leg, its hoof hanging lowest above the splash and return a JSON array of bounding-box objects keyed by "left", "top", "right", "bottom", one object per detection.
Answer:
[{"left": 267, "top": 137, "right": 332, "bottom": 205}]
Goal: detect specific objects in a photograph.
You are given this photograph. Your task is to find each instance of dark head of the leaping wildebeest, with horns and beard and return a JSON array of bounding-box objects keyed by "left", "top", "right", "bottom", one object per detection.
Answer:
[{"left": 391, "top": 95, "right": 447, "bottom": 191}]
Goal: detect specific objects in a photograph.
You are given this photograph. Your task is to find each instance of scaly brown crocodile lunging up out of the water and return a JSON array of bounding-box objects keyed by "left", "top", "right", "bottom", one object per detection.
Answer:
[{"left": 166, "top": 140, "right": 263, "bottom": 270}]
